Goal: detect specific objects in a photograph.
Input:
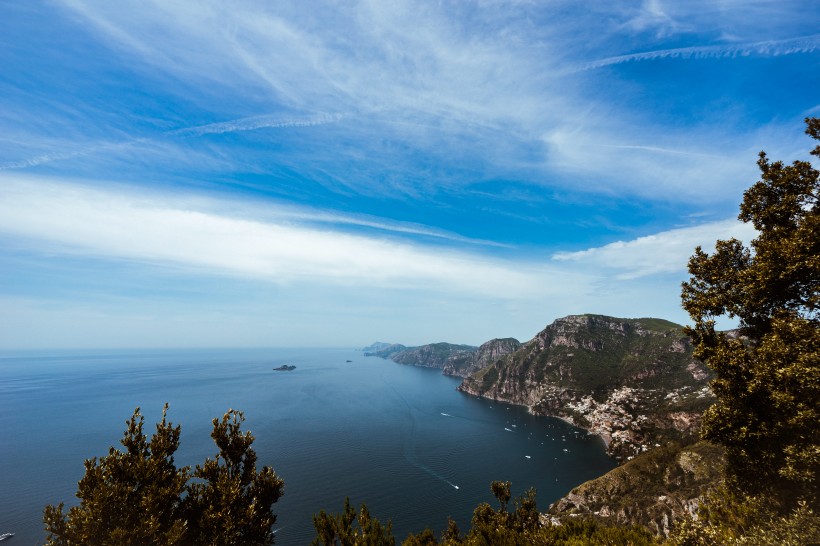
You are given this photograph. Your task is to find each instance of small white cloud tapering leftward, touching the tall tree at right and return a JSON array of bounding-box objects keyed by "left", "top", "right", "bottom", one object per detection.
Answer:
[{"left": 553, "top": 220, "right": 756, "bottom": 280}]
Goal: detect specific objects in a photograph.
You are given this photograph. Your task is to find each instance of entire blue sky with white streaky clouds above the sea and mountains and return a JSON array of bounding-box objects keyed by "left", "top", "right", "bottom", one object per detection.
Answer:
[{"left": 0, "top": 0, "right": 820, "bottom": 350}]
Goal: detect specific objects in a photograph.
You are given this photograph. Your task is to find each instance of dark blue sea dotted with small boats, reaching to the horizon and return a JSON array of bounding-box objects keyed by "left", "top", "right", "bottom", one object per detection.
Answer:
[{"left": 0, "top": 349, "right": 615, "bottom": 546}]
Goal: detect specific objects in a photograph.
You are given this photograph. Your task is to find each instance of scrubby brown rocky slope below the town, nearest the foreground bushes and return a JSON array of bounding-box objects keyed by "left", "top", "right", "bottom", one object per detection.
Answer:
[{"left": 548, "top": 442, "right": 725, "bottom": 536}]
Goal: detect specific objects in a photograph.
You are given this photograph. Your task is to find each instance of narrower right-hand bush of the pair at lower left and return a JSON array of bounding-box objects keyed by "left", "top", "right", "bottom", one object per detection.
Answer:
[{"left": 185, "top": 410, "right": 284, "bottom": 546}]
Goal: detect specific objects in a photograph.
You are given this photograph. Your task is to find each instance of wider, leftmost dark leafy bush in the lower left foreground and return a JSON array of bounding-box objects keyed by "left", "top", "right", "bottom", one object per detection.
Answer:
[{"left": 43, "top": 404, "right": 188, "bottom": 546}]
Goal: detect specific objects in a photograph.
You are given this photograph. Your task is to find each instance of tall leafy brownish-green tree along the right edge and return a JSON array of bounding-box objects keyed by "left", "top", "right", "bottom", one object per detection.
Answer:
[{"left": 681, "top": 118, "right": 820, "bottom": 513}]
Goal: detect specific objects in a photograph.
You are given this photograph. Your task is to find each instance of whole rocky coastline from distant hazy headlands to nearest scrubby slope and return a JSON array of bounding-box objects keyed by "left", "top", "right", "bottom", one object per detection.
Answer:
[{"left": 366, "top": 315, "right": 723, "bottom": 535}]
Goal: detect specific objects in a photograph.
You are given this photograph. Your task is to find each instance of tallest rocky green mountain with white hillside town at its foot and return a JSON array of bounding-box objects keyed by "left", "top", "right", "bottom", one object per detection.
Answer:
[{"left": 459, "top": 315, "right": 713, "bottom": 460}]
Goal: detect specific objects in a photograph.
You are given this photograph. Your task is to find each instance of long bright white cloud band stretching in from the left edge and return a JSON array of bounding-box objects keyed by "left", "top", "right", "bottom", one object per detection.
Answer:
[{"left": 0, "top": 177, "right": 556, "bottom": 298}]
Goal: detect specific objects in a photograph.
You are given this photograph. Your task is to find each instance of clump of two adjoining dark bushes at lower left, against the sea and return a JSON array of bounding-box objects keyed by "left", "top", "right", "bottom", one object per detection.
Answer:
[{"left": 43, "top": 405, "right": 284, "bottom": 546}]
